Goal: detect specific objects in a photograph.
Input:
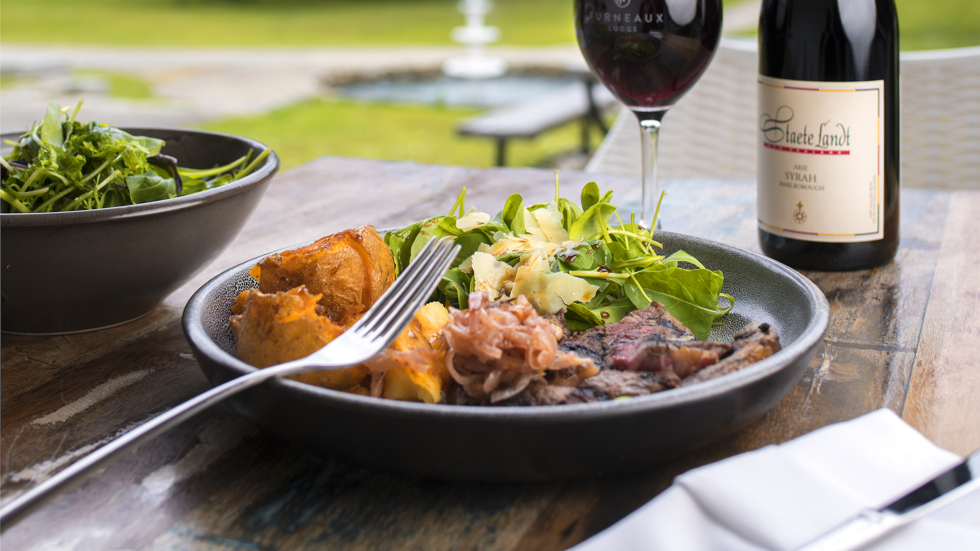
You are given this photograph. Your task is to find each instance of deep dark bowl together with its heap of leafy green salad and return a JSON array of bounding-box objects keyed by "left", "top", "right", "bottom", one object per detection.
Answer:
[{"left": 0, "top": 103, "right": 279, "bottom": 333}]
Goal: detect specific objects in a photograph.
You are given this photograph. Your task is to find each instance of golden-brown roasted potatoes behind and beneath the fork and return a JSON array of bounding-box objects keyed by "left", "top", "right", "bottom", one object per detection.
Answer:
[{"left": 230, "top": 226, "right": 449, "bottom": 403}]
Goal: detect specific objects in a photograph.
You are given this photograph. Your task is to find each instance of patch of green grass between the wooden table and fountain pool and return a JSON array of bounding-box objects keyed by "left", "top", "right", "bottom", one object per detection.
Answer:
[{"left": 200, "top": 99, "right": 602, "bottom": 169}]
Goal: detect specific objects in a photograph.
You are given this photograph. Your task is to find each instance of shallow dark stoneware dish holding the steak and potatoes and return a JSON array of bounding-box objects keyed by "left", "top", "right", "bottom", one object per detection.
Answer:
[{"left": 183, "top": 232, "right": 830, "bottom": 480}]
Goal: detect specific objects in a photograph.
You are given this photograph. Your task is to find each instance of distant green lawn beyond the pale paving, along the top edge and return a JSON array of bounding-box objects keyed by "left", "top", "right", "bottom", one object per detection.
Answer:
[{"left": 0, "top": 0, "right": 980, "bottom": 50}]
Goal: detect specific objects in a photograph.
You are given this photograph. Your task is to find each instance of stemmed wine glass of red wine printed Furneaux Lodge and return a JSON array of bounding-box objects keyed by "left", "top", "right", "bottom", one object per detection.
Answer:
[{"left": 575, "top": 0, "right": 721, "bottom": 230}]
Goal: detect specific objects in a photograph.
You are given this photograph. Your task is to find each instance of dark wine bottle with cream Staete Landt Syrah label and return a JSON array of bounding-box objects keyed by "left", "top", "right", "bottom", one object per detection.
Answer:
[{"left": 757, "top": 0, "right": 899, "bottom": 270}]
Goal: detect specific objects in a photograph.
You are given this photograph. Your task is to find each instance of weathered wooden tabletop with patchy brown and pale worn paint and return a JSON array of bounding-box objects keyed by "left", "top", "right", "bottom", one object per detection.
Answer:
[{"left": 0, "top": 158, "right": 980, "bottom": 551}]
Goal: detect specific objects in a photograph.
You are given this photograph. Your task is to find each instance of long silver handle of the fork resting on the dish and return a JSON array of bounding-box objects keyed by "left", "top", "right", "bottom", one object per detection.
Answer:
[{"left": 0, "top": 366, "right": 282, "bottom": 530}]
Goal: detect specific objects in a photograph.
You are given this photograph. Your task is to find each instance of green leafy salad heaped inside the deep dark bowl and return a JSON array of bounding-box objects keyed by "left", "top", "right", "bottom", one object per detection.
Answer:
[{"left": 0, "top": 101, "right": 269, "bottom": 213}]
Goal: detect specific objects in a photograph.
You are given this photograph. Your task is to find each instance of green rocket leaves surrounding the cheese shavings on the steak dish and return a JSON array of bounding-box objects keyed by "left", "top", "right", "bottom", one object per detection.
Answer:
[{"left": 385, "top": 182, "right": 734, "bottom": 339}]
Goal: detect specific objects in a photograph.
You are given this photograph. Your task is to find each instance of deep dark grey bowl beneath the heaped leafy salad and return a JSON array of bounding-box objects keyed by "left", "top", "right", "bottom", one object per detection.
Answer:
[{"left": 0, "top": 128, "right": 279, "bottom": 333}]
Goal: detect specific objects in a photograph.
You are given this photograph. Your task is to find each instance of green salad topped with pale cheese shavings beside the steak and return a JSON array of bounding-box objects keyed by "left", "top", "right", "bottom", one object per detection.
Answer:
[{"left": 385, "top": 179, "right": 734, "bottom": 339}]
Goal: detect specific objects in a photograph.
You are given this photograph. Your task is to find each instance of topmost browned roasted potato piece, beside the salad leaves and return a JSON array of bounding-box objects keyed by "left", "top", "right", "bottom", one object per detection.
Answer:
[{"left": 251, "top": 226, "right": 395, "bottom": 325}]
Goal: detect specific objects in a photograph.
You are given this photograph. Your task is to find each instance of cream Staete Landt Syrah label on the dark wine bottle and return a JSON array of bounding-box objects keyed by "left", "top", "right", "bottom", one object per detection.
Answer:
[{"left": 757, "top": 75, "right": 885, "bottom": 243}]
